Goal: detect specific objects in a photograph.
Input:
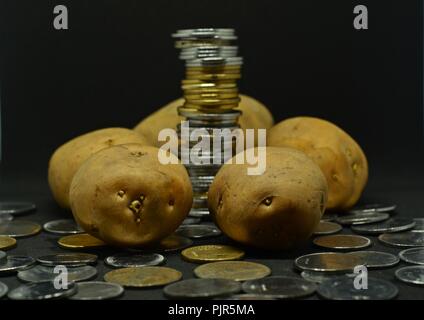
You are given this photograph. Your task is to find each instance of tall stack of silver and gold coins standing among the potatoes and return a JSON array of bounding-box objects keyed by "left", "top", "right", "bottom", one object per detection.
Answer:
[{"left": 172, "top": 28, "right": 243, "bottom": 217}]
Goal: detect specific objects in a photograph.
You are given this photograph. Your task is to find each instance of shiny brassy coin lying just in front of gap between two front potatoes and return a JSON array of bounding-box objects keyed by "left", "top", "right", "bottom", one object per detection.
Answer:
[{"left": 181, "top": 245, "right": 244, "bottom": 263}]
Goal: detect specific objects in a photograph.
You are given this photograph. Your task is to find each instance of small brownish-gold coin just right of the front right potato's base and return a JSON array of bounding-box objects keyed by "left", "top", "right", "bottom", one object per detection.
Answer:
[{"left": 313, "top": 234, "right": 371, "bottom": 250}]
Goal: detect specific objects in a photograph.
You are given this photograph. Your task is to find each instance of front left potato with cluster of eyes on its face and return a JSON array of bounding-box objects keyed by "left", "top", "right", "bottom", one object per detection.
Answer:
[{"left": 69, "top": 144, "right": 193, "bottom": 247}]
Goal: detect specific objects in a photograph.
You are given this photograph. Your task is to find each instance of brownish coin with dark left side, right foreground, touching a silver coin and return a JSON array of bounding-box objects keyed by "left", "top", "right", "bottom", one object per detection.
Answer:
[{"left": 294, "top": 252, "right": 362, "bottom": 273}]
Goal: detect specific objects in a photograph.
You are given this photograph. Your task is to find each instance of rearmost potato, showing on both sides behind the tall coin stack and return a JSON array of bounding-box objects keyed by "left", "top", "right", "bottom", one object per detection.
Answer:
[{"left": 134, "top": 95, "right": 274, "bottom": 147}]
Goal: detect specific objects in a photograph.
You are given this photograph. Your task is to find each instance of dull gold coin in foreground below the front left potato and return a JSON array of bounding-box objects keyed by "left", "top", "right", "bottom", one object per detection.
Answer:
[{"left": 104, "top": 267, "right": 182, "bottom": 288}]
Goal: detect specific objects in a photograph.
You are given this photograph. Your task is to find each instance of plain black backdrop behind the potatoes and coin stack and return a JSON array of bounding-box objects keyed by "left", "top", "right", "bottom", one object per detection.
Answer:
[{"left": 0, "top": 0, "right": 423, "bottom": 182}]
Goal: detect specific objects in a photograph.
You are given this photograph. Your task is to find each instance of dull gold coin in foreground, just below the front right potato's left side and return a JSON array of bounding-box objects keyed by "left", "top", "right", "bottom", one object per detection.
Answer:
[{"left": 194, "top": 261, "right": 271, "bottom": 281}]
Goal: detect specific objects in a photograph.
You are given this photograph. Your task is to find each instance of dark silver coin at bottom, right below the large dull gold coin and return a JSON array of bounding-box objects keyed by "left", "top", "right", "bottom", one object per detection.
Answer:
[{"left": 242, "top": 276, "right": 317, "bottom": 299}]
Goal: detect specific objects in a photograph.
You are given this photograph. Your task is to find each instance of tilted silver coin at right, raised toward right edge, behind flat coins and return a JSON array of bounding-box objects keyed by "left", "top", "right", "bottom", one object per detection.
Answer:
[{"left": 351, "top": 218, "right": 415, "bottom": 234}]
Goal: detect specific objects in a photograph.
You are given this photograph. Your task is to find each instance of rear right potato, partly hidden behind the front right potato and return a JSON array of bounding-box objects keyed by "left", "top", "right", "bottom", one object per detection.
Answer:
[{"left": 267, "top": 117, "right": 368, "bottom": 210}]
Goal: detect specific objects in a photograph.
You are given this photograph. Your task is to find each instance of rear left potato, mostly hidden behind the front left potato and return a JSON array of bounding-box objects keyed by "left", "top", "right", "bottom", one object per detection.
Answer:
[{"left": 48, "top": 128, "right": 149, "bottom": 208}]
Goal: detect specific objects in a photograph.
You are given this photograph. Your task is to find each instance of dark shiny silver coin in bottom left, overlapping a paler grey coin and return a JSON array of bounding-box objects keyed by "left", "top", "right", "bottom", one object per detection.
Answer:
[{"left": 7, "top": 281, "right": 77, "bottom": 300}]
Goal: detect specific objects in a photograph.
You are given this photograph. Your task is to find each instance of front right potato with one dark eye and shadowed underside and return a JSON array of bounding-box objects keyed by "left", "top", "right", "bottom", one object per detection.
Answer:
[{"left": 208, "top": 147, "right": 327, "bottom": 249}]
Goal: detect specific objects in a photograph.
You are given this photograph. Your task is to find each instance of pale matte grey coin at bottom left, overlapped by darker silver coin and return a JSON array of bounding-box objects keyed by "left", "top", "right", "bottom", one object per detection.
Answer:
[{"left": 69, "top": 281, "right": 124, "bottom": 300}]
